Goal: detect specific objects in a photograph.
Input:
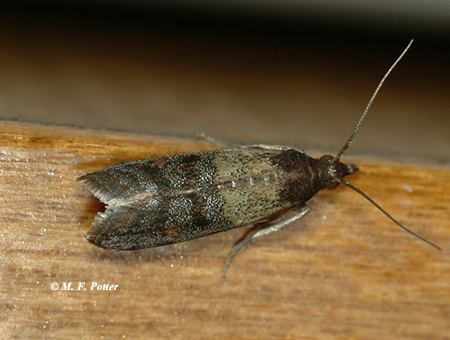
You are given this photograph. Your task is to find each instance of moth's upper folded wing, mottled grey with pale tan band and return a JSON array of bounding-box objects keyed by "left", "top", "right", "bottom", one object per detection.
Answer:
[{"left": 79, "top": 148, "right": 286, "bottom": 203}]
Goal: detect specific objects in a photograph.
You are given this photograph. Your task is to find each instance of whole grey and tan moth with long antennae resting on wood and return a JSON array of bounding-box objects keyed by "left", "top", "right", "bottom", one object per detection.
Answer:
[{"left": 79, "top": 40, "right": 441, "bottom": 278}]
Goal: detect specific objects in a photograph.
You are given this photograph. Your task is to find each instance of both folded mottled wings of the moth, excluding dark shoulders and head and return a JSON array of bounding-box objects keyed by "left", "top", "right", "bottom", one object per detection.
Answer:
[{"left": 80, "top": 148, "right": 310, "bottom": 250}]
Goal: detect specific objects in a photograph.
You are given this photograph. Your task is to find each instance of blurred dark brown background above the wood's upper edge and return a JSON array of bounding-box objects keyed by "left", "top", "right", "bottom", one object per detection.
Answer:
[{"left": 0, "top": 0, "right": 450, "bottom": 164}]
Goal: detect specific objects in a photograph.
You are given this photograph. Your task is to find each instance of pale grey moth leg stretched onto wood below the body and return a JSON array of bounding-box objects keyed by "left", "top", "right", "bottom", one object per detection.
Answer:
[{"left": 222, "top": 205, "right": 311, "bottom": 279}]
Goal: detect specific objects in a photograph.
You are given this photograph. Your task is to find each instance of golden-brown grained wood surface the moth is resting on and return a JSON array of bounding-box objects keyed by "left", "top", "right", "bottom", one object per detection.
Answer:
[{"left": 0, "top": 123, "right": 450, "bottom": 339}]
